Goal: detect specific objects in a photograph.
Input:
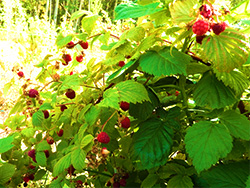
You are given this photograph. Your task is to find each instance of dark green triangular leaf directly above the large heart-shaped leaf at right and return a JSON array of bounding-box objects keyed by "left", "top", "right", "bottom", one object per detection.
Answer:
[{"left": 194, "top": 71, "right": 236, "bottom": 108}]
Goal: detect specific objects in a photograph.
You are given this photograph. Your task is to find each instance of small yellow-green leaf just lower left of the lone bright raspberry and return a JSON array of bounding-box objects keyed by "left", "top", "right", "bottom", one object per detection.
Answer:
[{"left": 71, "top": 148, "right": 86, "bottom": 170}]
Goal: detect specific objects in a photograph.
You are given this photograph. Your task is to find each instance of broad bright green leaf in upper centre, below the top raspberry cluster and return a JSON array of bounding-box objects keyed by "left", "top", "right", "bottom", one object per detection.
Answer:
[{"left": 139, "top": 47, "right": 191, "bottom": 76}]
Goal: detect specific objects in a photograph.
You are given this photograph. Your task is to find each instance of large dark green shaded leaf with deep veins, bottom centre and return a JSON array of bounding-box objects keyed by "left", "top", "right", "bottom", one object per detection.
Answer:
[{"left": 130, "top": 118, "right": 173, "bottom": 170}]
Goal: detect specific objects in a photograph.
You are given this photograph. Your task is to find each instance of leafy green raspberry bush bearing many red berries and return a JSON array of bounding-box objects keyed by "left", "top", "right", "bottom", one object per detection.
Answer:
[{"left": 0, "top": 0, "right": 250, "bottom": 188}]
